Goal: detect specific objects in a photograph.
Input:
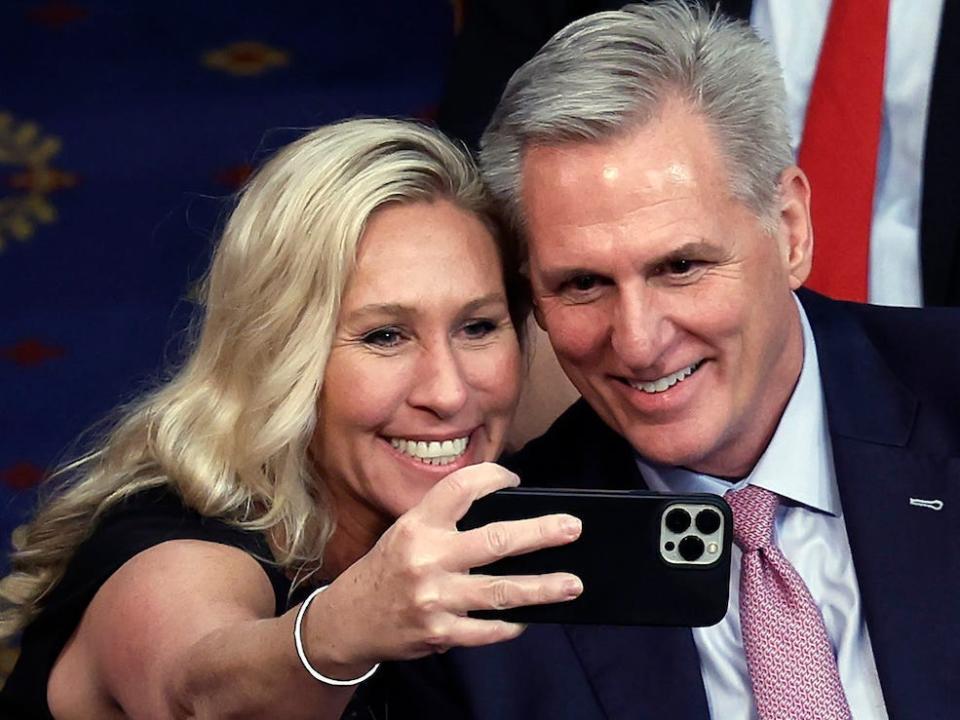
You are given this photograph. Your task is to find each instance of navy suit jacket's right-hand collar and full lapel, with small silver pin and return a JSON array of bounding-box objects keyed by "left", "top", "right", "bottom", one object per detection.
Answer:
[{"left": 801, "top": 293, "right": 960, "bottom": 718}]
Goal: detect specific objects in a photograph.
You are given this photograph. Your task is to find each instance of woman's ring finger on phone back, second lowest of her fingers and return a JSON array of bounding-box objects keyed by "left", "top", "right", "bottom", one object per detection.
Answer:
[{"left": 444, "top": 573, "right": 583, "bottom": 614}]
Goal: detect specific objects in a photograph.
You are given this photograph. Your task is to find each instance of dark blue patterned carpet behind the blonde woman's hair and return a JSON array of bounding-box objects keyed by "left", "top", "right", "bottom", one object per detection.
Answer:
[{"left": 0, "top": 0, "right": 459, "bottom": 559}]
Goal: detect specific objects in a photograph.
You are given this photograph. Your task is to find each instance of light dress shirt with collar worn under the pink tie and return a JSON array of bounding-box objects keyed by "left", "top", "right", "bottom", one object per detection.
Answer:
[{"left": 637, "top": 302, "right": 887, "bottom": 720}]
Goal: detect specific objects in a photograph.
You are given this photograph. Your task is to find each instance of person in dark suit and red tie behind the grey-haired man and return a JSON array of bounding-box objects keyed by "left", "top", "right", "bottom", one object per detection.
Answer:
[{"left": 446, "top": 0, "right": 960, "bottom": 448}]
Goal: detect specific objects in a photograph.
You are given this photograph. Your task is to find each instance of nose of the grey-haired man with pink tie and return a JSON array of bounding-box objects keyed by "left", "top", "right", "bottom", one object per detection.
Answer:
[{"left": 610, "top": 292, "right": 670, "bottom": 370}]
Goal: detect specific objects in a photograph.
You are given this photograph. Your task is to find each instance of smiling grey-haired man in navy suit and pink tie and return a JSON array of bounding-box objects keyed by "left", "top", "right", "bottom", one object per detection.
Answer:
[{"left": 384, "top": 2, "right": 960, "bottom": 720}]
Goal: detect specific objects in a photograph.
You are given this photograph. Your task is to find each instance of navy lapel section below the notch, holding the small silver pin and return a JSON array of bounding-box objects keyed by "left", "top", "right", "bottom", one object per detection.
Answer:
[{"left": 833, "top": 437, "right": 960, "bottom": 718}]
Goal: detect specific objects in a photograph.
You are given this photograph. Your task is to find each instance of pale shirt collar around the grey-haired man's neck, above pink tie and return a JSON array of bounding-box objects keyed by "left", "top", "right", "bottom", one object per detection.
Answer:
[{"left": 637, "top": 296, "right": 840, "bottom": 515}]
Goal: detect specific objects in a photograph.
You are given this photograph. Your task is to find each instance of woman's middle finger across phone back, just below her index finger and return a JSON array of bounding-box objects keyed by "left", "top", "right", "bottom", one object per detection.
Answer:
[{"left": 451, "top": 514, "right": 582, "bottom": 570}]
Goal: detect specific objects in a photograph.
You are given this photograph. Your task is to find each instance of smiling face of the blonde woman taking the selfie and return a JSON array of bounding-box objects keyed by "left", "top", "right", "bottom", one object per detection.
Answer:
[{"left": 312, "top": 200, "right": 521, "bottom": 529}]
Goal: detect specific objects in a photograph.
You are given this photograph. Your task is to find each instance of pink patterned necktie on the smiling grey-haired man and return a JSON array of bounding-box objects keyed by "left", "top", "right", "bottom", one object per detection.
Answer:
[{"left": 725, "top": 485, "right": 851, "bottom": 720}]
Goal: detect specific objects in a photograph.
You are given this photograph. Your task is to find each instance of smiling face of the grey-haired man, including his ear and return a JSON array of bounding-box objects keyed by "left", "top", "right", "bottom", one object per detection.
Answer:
[{"left": 522, "top": 102, "right": 812, "bottom": 477}]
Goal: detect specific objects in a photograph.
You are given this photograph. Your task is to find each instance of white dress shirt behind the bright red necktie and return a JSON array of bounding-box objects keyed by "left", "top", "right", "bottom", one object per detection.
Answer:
[{"left": 750, "top": 0, "right": 950, "bottom": 307}]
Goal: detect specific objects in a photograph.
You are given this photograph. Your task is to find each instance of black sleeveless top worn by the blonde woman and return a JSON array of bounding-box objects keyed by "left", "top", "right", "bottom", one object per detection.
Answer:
[{"left": 0, "top": 488, "right": 461, "bottom": 720}]
